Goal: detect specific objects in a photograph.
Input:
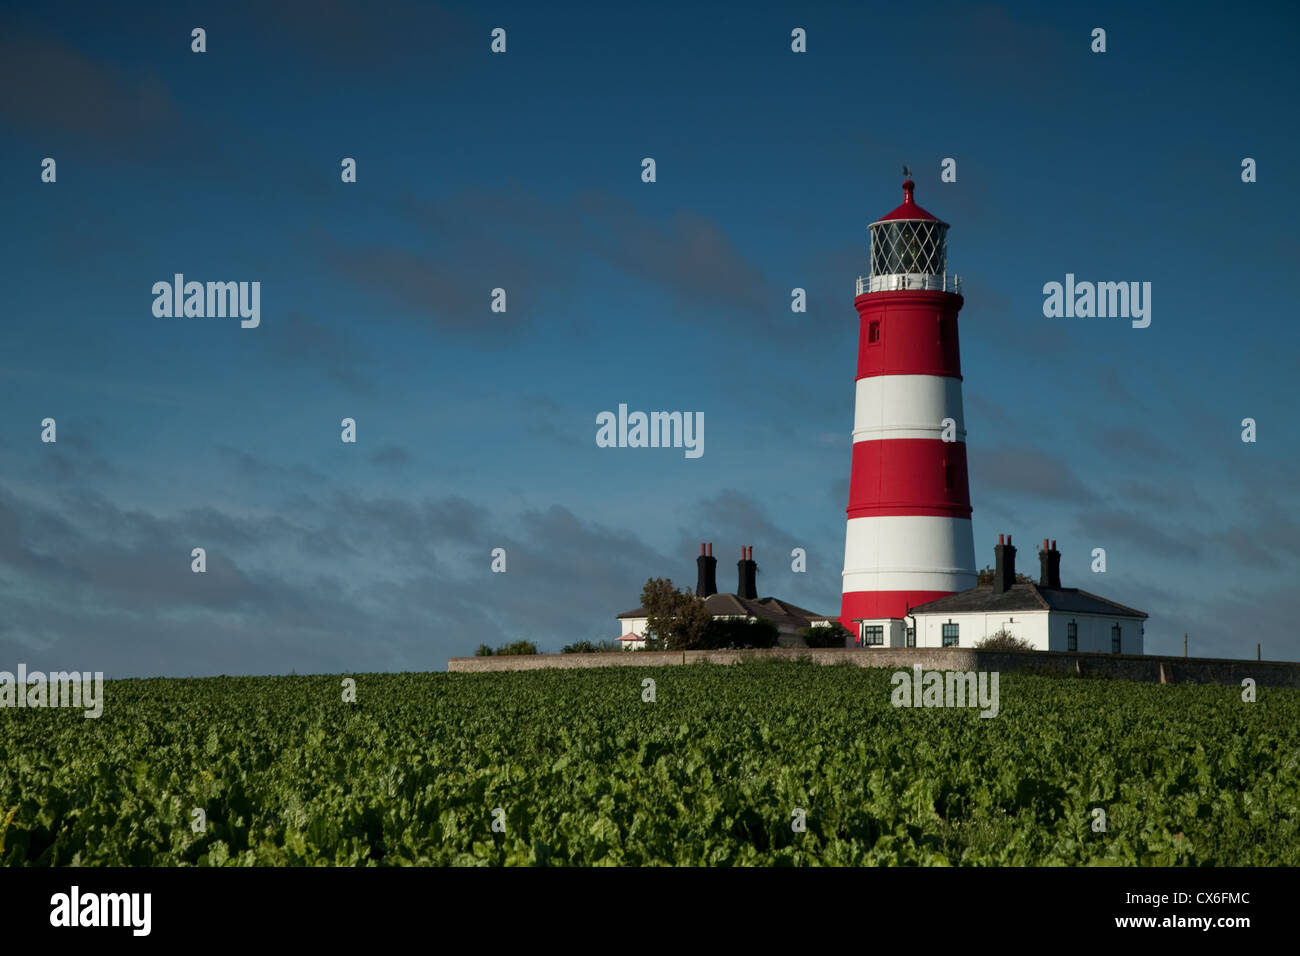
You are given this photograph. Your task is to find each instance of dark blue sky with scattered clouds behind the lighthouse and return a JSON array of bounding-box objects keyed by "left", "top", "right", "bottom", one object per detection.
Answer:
[{"left": 0, "top": 0, "right": 1300, "bottom": 676}]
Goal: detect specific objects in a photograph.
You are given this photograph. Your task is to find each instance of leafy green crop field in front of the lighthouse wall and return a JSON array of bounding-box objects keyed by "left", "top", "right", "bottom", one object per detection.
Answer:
[{"left": 0, "top": 662, "right": 1300, "bottom": 866}]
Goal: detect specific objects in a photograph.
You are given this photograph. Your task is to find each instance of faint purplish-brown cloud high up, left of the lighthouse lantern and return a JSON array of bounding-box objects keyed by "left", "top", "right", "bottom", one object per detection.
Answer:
[{"left": 330, "top": 185, "right": 789, "bottom": 339}]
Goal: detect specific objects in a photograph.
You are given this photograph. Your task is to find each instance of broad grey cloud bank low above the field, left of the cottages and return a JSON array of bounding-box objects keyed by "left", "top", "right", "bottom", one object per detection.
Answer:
[{"left": 0, "top": 484, "right": 686, "bottom": 676}]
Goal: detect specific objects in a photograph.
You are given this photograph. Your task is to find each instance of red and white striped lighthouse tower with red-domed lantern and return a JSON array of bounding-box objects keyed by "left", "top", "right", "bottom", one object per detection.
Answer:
[{"left": 840, "top": 166, "right": 976, "bottom": 646}]
